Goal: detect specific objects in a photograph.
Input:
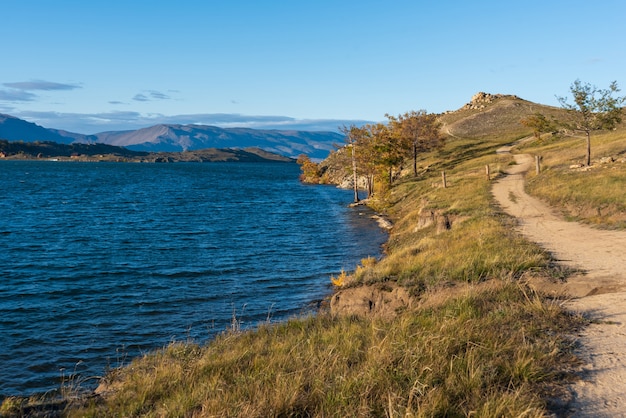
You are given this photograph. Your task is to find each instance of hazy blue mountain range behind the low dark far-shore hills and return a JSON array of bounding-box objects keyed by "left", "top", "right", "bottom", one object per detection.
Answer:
[{"left": 0, "top": 114, "right": 343, "bottom": 159}]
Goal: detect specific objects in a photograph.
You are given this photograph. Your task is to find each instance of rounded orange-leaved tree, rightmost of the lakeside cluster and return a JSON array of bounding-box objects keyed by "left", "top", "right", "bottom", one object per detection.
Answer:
[{"left": 385, "top": 110, "right": 444, "bottom": 176}]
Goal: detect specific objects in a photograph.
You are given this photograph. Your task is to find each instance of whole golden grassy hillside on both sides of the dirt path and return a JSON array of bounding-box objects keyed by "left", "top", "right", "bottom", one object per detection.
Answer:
[{"left": 0, "top": 96, "right": 626, "bottom": 417}]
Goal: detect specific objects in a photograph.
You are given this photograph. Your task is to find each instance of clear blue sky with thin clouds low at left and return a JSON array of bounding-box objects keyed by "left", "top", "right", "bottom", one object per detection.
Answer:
[{"left": 0, "top": 0, "right": 626, "bottom": 133}]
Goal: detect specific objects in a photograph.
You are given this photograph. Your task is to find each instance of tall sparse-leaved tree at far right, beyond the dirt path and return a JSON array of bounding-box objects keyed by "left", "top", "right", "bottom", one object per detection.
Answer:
[{"left": 557, "top": 80, "right": 626, "bottom": 166}]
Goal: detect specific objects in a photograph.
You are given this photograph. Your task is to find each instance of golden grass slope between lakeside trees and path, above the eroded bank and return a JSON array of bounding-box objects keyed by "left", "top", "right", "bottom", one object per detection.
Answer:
[{"left": 349, "top": 134, "right": 563, "bottom": 295}]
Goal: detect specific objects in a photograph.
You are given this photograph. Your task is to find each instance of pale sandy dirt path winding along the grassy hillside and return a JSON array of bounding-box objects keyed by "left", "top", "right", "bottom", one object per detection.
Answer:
[{"left": 493, "top": 147, "right": 626, "bottom": 417}]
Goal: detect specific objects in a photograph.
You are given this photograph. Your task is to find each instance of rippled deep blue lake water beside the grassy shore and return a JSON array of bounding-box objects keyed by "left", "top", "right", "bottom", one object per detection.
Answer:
[{"left": 0, "top": 161, "right": 387, "bottom": 399}]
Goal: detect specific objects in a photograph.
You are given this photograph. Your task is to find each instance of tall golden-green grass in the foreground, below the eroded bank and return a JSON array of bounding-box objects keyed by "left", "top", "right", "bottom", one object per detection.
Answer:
[{"left": 64, "top": 281, "right": 571, "bottom": 417}]
